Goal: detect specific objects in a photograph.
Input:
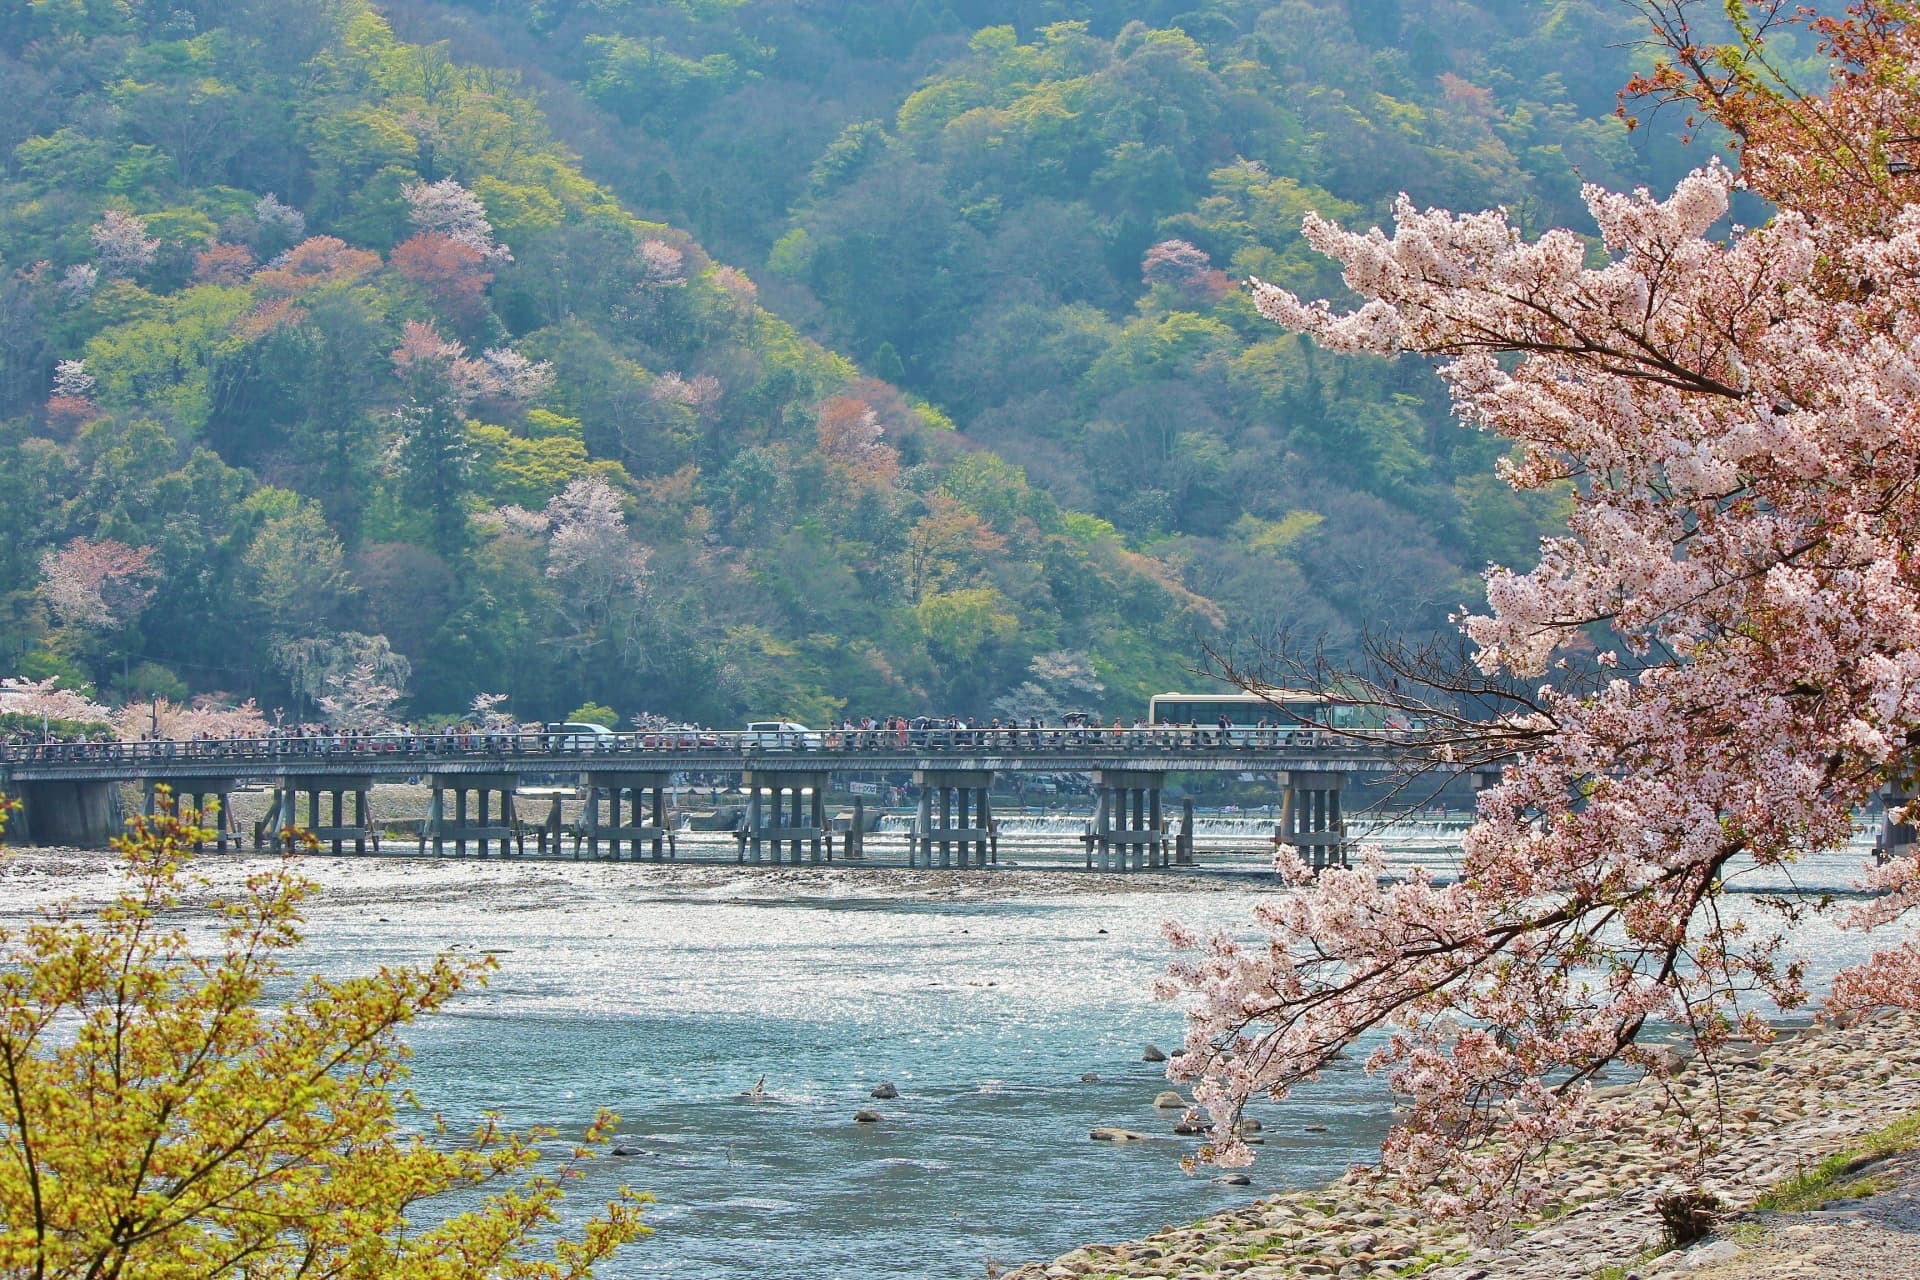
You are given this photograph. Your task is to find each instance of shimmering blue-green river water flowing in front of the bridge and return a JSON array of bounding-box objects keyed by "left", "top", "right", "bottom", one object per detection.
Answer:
[{"left": 224, "top": 833, "right": 1889, "bottom": 1280}]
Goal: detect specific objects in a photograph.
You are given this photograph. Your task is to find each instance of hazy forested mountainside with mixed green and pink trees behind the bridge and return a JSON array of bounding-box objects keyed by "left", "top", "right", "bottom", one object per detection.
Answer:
[{"left": 0, "top": 0, "right": 1697, "bottom": 722}]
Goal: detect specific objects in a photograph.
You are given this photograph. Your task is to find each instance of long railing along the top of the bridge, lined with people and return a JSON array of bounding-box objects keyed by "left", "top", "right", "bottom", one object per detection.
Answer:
[{"left": 0, "top": 725, "right": 1417, "bottom": 766}]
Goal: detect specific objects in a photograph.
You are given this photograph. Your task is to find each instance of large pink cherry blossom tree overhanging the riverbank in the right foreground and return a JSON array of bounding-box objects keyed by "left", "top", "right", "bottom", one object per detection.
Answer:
[{"left": 1162, "top": 4, "right": 1920, "bottom": 1234}]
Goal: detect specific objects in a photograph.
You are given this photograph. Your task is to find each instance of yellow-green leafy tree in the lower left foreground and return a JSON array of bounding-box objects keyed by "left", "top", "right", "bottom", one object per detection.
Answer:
[{"left": 0, "top": 804, "right": 647, "bottom": 1280}]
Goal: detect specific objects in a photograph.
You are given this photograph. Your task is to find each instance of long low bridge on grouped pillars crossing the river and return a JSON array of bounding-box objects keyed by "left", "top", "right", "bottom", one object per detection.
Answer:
[{"left": 0, "top": 725, "right": 1451, "bottom": 871}]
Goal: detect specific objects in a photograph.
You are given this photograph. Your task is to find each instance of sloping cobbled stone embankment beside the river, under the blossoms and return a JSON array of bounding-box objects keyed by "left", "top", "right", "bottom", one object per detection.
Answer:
[{"left": 1006, "top": 1013, "right": 1920, "bottom": 1280}]
